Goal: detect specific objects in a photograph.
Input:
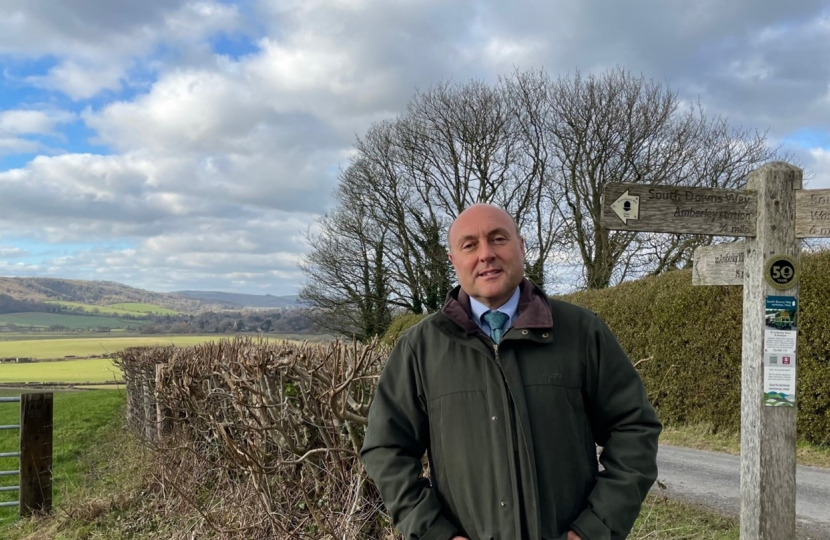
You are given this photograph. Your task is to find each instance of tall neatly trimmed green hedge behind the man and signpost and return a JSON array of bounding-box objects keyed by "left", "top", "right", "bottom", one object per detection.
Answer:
[{"left": 382, "top": 251, "right": 830, "bottom": 444}]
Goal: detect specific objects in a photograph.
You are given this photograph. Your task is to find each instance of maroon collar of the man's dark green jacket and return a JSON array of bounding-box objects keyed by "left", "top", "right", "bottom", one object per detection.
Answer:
[{"left": 441, "top": 278, "right": 553, "bottom": 334}]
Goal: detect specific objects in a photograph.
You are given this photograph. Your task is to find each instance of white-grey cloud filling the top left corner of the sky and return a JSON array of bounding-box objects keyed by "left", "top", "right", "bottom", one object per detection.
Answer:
[{"left": 0, "top": 0, "right": 240, "bottom": 100}]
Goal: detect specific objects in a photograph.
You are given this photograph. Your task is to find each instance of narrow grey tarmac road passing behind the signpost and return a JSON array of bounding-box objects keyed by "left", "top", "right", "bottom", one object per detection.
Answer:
[{"left": 652, "top": 445, "right": 830, "bottom": 540}]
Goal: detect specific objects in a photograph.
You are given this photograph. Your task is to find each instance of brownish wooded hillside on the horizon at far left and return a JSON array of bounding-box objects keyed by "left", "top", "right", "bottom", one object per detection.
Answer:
[{"left": 0, "top": 277, "right": 218, "bottom": 312}]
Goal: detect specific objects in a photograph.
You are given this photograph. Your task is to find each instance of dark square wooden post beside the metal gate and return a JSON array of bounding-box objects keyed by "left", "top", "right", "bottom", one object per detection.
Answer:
[{"left": 20, "top": 394, "right": 53, "bottom": 517}]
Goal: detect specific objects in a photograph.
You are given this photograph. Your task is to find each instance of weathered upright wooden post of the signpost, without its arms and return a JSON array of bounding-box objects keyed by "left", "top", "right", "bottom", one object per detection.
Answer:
[{"left": 741, "top": 163, "right": 802, "bottom": 540}]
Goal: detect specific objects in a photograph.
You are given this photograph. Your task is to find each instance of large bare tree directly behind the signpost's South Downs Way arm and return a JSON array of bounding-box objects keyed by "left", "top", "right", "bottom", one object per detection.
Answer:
[{"left": 536, "top": 68, "right": 775, "bottom": 288}]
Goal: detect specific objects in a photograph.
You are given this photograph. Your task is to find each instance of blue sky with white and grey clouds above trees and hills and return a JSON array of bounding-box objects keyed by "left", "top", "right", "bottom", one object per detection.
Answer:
[{"left": 0, "top": 0, "right": 830, "bottom": 295}]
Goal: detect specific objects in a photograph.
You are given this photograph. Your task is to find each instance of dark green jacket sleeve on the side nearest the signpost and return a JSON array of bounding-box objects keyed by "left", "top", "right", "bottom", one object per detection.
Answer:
[{"left": 572, "top": 316, "right": 662, "bottom": 540}]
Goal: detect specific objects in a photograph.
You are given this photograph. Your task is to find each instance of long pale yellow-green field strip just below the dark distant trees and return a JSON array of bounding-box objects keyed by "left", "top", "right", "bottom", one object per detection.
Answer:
[{"left": 0, "top": 334, "right": 294, "bottom": 359}]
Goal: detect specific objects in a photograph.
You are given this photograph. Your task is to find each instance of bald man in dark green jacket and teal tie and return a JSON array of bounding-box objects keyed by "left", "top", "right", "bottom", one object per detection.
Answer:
[{"left": 361, "top": 204, "right": 661, "bottom": 540}]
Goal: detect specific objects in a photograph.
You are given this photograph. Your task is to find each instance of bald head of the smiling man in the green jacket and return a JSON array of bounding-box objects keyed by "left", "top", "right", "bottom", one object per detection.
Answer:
[{"left": 449, "top": 204, "right": 525, "bottom": 308}]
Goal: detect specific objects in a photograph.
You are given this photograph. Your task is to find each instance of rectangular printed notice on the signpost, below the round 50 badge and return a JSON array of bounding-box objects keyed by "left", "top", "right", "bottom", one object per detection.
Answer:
[{"left": 764, "top": 296, "right": 798, "bottom": 407}]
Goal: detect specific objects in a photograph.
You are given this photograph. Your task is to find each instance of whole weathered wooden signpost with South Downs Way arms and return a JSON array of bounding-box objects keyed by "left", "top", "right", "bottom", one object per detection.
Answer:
[{"left": 602, "top": 162, "right": 830, "bottom": 540}]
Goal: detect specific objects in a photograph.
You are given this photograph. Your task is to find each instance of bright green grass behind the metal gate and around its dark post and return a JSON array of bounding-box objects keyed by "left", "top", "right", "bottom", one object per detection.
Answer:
[{"left": 0, "top": 390, "right": 126, "bottom": 524}]
